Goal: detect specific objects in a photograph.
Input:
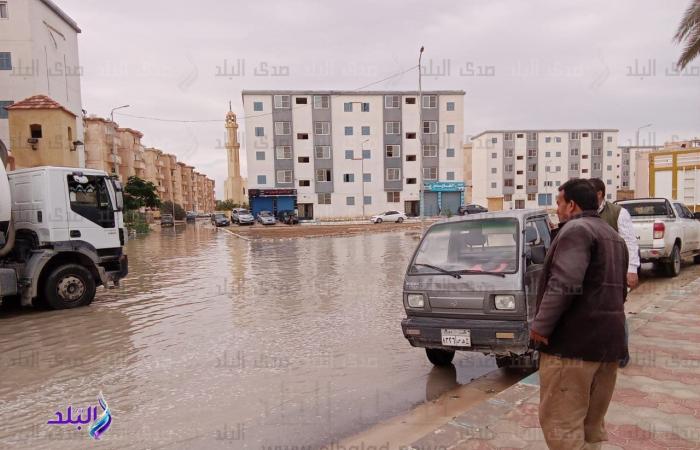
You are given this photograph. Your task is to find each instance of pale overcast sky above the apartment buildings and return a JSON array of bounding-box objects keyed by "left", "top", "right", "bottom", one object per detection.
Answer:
[{"left": 60, "top": 0, "right": 700, "bottom": 198}]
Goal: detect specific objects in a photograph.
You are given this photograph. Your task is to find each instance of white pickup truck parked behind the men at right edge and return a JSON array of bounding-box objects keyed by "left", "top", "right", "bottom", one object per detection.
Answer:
[{"left": 617, "top": 198, "right": 700, "bottom": 277}]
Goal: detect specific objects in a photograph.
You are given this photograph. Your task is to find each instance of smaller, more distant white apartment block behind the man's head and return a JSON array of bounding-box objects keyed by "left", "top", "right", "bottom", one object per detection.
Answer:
[{"left": 472, "top": 129, "right": 629, "bottom": 211}]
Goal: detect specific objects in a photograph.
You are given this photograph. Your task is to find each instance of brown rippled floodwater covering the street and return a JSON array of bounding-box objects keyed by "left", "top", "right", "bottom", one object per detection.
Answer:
[{"left": 0, "top": 222, "right": 495, "bottom": 449}]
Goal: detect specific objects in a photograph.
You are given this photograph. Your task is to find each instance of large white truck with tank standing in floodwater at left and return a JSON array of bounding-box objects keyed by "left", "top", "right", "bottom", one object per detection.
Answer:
[{"left": 0, "top": 149, "right": 128, "bottom": 309}]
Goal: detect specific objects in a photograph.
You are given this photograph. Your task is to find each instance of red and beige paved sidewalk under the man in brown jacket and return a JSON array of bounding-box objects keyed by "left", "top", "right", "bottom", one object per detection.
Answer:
[{"left": 410, "top": 272, "right": 700, "bottom": 450}]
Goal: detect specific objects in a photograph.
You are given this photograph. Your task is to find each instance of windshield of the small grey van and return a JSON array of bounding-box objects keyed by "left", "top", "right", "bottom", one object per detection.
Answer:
[{"left": 410, "top": 218, "right": 518, "bottom": 274}]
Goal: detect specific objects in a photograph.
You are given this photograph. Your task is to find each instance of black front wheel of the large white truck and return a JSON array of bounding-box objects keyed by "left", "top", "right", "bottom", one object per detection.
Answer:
[{"left": 44, "top": 264, "right": 96, "bottom": 309}]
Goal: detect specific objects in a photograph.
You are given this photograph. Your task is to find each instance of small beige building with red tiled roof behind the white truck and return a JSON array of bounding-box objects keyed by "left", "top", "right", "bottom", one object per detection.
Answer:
[{"left": 5, "top": 95, "right": 83, "bottom": 169}]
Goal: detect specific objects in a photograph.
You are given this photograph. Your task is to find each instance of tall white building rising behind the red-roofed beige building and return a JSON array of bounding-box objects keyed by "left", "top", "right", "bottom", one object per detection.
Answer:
[{"left": 0, "top": 0, "right": 85, "bottom": 166}]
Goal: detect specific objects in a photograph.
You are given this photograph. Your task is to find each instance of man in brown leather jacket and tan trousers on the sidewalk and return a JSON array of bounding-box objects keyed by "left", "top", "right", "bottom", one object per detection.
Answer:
[{"left": 530, "top": 179, "right": 628, "bottom": 449}]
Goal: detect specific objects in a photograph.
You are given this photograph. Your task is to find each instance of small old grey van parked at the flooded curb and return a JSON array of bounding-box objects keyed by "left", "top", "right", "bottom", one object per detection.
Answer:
[{"left": 401, "top": 210, "right": 551, "bottom": 369}]
